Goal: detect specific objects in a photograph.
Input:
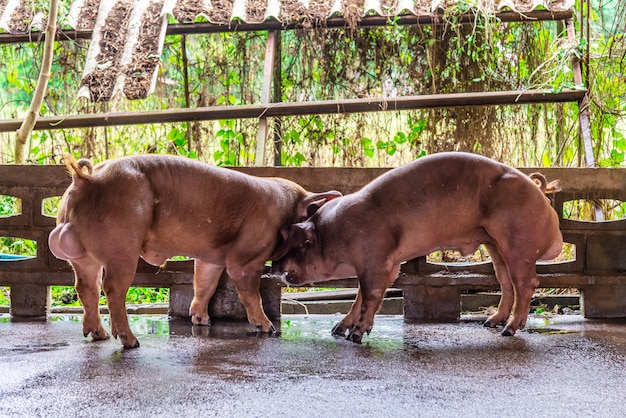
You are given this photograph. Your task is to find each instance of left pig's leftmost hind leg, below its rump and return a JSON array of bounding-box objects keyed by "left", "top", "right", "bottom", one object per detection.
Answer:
[{"left": 70, "top": 256, "right": 109, "bottom": 340}]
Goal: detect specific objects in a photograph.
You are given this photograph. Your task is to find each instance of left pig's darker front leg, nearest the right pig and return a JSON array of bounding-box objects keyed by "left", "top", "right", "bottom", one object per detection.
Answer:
[{"left": 227, "top": 263, "right": 276, "bottom": 333}]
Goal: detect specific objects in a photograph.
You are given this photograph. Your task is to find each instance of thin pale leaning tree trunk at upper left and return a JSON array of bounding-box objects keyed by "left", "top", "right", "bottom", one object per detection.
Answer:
[{"left": 15, "top": 0, "right": 59, "bottom": 164}]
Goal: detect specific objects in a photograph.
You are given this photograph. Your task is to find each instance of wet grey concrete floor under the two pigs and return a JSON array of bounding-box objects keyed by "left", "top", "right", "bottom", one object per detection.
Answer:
[{"left": 0, "top": 315, "right": 626, "bottom": 418}]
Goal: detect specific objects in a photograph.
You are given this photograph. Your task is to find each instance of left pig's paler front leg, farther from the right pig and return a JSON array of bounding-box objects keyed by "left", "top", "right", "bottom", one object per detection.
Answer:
[{"left": 189, "top": 259, "right": 224, "bottom": 325}]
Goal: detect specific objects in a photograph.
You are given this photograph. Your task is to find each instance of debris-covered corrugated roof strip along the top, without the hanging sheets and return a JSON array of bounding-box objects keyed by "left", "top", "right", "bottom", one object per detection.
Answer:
[{"left": 0, "top": 0, "right": 574, "bottom": 33}]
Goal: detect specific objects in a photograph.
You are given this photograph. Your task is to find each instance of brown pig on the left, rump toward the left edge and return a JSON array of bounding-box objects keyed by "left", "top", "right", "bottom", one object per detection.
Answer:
[{"left": 49, "top": 155, "right": 340, "bottom": 348}]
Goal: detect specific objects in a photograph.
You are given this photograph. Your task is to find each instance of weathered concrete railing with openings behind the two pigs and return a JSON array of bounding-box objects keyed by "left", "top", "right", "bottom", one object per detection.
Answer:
[{"left": 0, "top": 165, "right": 626, "bottom": 320}]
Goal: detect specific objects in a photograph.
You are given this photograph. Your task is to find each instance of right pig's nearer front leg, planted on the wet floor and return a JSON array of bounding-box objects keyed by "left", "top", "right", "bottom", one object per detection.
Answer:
[{"left": 347, "top": 264, "right": 400, "bottom": 344}]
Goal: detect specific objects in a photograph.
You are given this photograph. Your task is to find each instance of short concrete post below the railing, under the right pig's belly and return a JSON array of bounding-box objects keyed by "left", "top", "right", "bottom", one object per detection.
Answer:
[{"left": 402, "top": 285, "right": 461, "bottom": 321}]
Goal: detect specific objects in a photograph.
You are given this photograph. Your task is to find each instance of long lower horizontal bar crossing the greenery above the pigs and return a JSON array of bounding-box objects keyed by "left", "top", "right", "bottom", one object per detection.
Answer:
[{"left": 0, "top": 89, "right": 586, "bottom": 132}]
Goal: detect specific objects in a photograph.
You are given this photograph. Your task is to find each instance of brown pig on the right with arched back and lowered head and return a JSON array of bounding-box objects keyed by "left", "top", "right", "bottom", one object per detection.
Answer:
[{"left": 272, "top": 152, "right": 562, "bottom": 342}]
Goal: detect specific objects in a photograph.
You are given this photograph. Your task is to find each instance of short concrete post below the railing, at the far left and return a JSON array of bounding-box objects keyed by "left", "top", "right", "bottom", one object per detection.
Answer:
[{"left": 9, "top": 284, "right": 50, "bottom": 320}]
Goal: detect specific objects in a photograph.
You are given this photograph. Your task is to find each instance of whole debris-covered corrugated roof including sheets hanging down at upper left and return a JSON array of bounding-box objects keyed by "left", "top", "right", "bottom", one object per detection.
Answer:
[{"left": 0, "top": 0, "right": 574, "bottom": 101}]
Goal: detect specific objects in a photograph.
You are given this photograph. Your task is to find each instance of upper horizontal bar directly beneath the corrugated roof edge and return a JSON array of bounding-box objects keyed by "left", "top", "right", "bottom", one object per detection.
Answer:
[{"left": 0, "top": 10, "right": 573, "bottom": 44}]
